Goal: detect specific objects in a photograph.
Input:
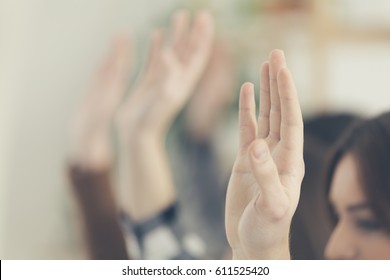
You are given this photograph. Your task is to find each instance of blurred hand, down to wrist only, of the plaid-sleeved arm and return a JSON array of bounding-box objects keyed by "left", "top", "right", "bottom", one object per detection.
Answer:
[{"left": 119, "top": 11, "right": 214, "bottom": 138}]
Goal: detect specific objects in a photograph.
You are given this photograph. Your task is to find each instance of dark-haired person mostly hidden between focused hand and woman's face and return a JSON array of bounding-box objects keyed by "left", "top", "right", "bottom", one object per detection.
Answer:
[{"left": 290, "top": 113, "right": 360, "bottom": 260}]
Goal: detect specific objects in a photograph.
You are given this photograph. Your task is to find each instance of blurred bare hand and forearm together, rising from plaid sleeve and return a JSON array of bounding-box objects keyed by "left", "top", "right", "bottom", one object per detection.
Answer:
[{"left": 116, "top": 11, "right": 214, "bottom": 222}]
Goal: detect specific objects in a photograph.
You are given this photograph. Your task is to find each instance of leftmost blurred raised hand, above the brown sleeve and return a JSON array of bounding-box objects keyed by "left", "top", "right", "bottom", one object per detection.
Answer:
[{"left": 70, "top": 36, "right": 132, "bottom": 170}]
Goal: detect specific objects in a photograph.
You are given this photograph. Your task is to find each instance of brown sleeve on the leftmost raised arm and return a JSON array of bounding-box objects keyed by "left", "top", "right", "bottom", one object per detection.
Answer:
[{"left": 69, "top": 164, "right": 128, "bottom": 259}]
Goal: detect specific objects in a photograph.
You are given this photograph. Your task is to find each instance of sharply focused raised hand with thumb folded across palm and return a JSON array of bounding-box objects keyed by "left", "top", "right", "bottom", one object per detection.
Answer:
[{"left": 225, "top": 50, "right": 305, "bottom": 259}]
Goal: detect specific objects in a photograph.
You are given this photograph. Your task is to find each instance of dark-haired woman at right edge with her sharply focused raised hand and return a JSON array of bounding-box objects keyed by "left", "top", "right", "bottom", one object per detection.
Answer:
[{"left": 225, "top": 50, "right": 390, "bottom": 259}]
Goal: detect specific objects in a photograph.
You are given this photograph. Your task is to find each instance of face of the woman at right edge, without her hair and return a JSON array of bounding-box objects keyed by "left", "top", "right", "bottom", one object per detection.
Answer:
[{"left": 325, "top": 154, "right": 390, "bottom": 260}]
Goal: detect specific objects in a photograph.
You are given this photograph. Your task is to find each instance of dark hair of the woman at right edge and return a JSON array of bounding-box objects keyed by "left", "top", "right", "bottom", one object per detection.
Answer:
[{"left": 325, "top": 112, "right": 390, "bottom": 233}]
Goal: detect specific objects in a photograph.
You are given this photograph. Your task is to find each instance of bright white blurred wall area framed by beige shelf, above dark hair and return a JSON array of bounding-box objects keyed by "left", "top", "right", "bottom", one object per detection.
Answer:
[{"left": 327, "top": 40, "right": 390, "bottom": 115}]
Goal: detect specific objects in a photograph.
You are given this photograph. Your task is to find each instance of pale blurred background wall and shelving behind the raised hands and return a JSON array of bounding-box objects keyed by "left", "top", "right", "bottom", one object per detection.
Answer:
[{"left": 0, "top": 0, "right": 390, "bottom": 259}]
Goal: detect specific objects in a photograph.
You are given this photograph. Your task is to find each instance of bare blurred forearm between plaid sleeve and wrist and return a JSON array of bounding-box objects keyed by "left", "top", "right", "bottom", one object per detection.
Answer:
[{"left": 125, "top": 133, "right": 176, "bottom": 222}]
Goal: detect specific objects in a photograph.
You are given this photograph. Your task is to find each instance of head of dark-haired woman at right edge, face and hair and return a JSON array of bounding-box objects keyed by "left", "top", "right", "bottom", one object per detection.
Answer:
[{"left": 325, "top": 113, "right": 390, "bottom": 259}]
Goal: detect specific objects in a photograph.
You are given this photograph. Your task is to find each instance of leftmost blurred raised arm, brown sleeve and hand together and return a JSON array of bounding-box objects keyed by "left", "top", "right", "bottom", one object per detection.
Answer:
[{"left": 68, "top": 36, "right": 132, "bottom": 259}]
